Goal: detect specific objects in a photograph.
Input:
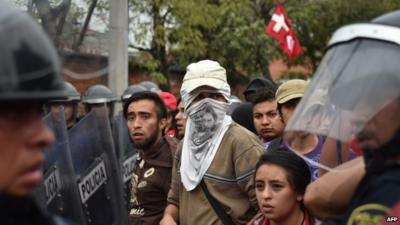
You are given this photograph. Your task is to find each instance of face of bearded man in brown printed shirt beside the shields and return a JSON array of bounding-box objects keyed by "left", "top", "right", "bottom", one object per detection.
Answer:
[{"left": 127, "top": 99, "right": 166, "bottom": 150}]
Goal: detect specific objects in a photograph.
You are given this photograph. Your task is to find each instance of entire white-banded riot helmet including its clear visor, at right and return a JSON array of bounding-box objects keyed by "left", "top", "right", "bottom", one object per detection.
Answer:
[{"left": 284, "top": 12, "right": 400, "bottom": 170}]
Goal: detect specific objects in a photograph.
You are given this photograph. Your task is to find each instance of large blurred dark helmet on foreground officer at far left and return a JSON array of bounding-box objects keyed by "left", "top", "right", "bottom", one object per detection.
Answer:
[{"left": 0, "top": 1, "right": 65, "bottom": 101}]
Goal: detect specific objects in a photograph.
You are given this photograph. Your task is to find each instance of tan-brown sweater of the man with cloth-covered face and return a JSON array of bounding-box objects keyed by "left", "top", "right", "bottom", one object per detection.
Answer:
[{"left": 168, "top": 123, "right": 264, "bottom": 225}]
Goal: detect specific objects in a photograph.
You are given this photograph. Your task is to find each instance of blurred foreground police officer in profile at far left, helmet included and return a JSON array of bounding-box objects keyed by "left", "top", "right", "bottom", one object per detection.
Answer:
[{"left": 0, "top": 0, "right": 71, "bottom": 225}]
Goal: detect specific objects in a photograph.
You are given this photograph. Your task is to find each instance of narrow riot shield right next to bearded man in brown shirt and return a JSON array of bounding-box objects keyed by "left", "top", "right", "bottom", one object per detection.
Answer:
[{"left": 111, "top": 112, "right": 137, "bottom": 209}]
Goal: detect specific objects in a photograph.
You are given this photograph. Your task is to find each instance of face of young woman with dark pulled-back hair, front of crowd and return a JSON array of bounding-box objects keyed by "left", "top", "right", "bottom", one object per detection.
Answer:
[{"left": 255, "top": 164, "right": 303, "bottom": 224}]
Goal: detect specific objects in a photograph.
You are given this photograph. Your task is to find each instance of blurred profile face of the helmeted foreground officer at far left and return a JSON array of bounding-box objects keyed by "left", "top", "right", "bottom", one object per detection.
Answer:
[{"left": 0, "top": 102, "right": 54, "bottom": 196}]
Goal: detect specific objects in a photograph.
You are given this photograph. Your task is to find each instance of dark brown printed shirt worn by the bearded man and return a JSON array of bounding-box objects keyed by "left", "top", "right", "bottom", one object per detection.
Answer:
[{"left": 129, "top": 136, "right": 177, "bottom": 225}]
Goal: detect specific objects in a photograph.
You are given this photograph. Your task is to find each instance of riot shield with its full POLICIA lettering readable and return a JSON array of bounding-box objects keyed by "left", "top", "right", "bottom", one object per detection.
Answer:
[{"left": 69, "top": 105, "right": 128, "bottom": 225}]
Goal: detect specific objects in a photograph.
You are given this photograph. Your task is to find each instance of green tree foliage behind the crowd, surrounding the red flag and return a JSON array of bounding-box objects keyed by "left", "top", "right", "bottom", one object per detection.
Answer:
[{"left": 130, "top": 0, "right": 400, "bottom": 83}]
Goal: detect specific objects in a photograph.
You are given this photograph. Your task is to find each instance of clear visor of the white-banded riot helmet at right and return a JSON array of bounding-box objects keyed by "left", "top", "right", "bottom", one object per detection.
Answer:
[{"left": 284, "top": 39, "right": 400, "bottom": 170}]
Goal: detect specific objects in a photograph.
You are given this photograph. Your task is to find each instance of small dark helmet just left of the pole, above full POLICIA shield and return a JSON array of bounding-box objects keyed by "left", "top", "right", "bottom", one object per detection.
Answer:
[{"left": 82, "top": 84, "right": 117, "bottom": 104}]
